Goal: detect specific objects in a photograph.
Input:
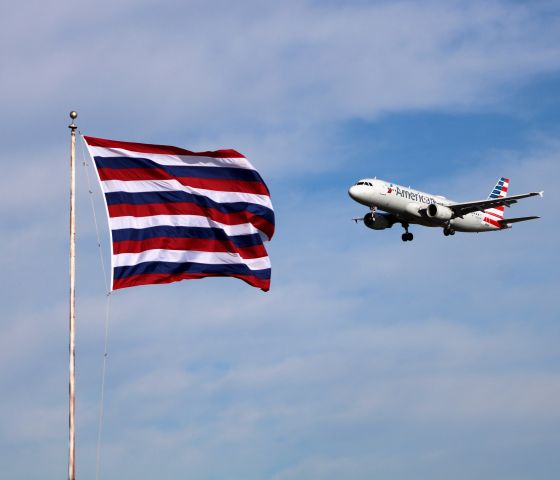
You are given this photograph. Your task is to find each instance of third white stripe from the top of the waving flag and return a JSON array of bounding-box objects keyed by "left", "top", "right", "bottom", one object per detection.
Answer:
[{"left": 109, "top": 215, "right": 268, "bottom": 240}]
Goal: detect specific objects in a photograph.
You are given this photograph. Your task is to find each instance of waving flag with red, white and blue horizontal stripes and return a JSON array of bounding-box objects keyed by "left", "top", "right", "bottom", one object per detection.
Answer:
[{"left": 83, "top": 136, "right": 274, "bottom": 291}]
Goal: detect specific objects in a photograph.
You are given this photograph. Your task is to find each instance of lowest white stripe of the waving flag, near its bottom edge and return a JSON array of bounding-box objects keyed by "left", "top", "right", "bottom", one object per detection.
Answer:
[{"left": 113, "top": 249, "right": 270, "bottom": 270}]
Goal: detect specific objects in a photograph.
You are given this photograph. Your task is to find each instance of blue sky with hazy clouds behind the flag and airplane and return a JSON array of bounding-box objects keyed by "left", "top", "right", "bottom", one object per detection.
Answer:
[{"left": 0, "top": 0, "right": 560, "bottom": 480}]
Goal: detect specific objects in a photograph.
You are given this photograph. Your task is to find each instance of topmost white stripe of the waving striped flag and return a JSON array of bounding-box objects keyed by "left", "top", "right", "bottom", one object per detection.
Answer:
[{"left": 88, "top": 147, "right": 255, "bottom": 170}]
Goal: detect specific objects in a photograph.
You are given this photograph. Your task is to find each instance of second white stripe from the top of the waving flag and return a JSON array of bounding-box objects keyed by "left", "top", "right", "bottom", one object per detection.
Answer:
[{"left": 101, "top": 180, "right": 272, "bottom": 210}]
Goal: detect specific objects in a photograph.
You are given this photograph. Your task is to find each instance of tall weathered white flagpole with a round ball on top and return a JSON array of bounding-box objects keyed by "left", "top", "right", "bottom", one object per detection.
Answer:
[{"left": 68, "top": 111, "right": 78, "bottom": 480}]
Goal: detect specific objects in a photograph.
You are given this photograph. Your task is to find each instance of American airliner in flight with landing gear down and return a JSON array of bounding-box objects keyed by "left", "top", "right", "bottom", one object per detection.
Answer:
[{"left": 348, "top": 177, "right": 544, "bottom": 242}]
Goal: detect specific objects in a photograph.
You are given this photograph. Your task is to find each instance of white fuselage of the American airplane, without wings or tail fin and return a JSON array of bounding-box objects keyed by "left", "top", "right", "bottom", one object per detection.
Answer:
[{"left": 348, "top": 178, "right": 498, "bottom": 232}]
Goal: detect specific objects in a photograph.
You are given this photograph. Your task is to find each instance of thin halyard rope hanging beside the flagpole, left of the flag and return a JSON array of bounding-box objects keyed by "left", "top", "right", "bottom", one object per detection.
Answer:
[{"left": 80, "top": 136, "right": 111, "bottom": 480}]
